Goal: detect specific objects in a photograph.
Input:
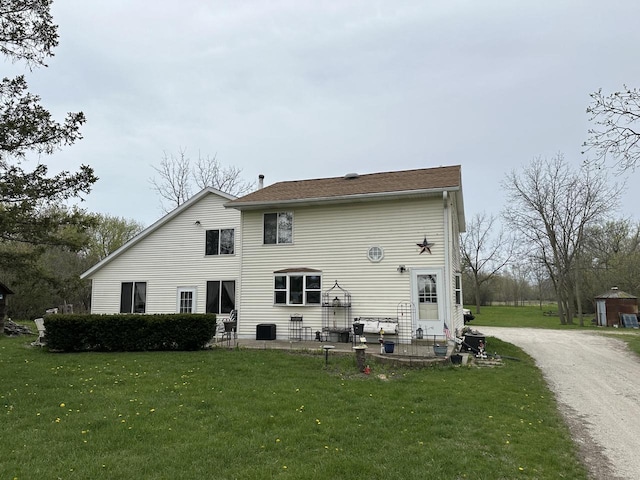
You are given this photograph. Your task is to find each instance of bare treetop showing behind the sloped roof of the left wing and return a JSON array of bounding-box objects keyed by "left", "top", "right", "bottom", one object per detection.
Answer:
[{"left": 149, "top": 148, "right": 255, "bottom": 213}]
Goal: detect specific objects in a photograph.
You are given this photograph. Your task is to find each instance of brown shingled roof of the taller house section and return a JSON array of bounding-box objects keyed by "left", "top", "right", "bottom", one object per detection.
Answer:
[{"left": 227, "top": 165, "right": 461, "bottom": 209}]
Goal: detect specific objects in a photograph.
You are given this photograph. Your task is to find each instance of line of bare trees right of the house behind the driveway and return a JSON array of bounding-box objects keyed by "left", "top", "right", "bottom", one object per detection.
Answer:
[{"left": 460, "top": 155, "right": 640, "bottom": 325}]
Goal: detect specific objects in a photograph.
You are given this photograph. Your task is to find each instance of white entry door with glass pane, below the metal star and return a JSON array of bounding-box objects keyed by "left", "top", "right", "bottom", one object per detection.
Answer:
[{"left": 411, "top": 269, "right": 444, "bottom": 338}]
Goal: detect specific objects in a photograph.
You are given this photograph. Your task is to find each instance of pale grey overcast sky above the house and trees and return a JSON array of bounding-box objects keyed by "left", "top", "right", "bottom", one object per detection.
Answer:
[{"left": 4, "top": 0, "right": 640, "bottom": 225}]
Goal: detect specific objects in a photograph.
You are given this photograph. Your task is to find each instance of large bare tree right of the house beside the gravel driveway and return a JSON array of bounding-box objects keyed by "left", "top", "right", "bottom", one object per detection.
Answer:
[{"left": 503, "top": 154, "right": 619, "bottom": 324}]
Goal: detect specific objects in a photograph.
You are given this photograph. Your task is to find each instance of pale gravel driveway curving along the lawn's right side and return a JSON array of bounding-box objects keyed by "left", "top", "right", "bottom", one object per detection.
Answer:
[{"left": 476, "top": 327, "right": 640, "bottom": 480}]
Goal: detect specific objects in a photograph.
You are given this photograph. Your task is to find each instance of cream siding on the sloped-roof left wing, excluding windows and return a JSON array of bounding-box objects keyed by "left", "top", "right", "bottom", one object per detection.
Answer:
[{"left": 91, "top": 194, "right": 242, "bottom": 314}]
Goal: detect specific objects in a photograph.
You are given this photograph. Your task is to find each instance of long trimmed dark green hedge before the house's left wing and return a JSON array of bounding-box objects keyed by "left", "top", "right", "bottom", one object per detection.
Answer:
[{"left": 44, "top": 314, "right": 216, "bottom": 352}]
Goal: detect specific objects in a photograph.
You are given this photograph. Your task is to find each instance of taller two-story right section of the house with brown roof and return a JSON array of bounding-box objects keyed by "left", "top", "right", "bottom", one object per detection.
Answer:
[{"left": 227, "top": 166, "right": 464, "bottom": 339}]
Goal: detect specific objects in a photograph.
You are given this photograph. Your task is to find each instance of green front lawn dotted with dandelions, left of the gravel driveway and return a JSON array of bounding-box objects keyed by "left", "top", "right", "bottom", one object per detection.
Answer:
[{"left": 0, "top": 330, "right": 586, "bottom": 480}]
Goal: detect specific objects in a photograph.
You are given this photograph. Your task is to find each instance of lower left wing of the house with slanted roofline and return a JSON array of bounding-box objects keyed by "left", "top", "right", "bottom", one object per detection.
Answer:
[{"left": 81, "top": 188, "right": 242, "bottom": 315}]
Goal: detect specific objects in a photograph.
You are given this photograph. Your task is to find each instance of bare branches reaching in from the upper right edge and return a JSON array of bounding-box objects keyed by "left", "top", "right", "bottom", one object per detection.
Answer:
[{"left": 583, "top": 85, "right": 640, "bottom": 172}]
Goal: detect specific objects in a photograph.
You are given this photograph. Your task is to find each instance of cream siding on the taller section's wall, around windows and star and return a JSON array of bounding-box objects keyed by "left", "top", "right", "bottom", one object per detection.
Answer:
[{"left": 238, "top": 196, "right": 445, "bottom": 338}]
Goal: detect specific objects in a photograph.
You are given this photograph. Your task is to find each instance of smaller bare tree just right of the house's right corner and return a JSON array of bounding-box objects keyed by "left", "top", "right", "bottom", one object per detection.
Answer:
[{"left": 460, "top": 212, "right": 515, "bottom": 313}]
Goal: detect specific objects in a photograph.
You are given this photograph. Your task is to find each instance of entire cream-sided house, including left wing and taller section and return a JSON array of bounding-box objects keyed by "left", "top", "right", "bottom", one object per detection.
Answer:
[{"left": 82, "top": 166, "right": 465, "bottom": 341}]
